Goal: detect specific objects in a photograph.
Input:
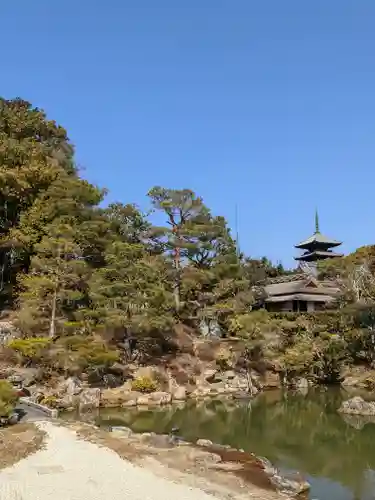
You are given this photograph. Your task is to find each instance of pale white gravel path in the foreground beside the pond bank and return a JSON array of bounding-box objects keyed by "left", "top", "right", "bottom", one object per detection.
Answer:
[{"left": 0, "top": 422, "right": 219, "bottom": 500}]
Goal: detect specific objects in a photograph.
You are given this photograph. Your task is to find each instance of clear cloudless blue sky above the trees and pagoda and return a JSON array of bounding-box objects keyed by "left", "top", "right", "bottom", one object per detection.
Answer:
[{"left": 0, "top": 0, "right": 375, "bottom": 265}]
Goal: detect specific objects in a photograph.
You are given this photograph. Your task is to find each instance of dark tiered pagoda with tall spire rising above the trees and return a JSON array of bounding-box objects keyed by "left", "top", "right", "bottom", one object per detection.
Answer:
[{"left": 295, "top": 211, "right": 343, "bottom": 264}]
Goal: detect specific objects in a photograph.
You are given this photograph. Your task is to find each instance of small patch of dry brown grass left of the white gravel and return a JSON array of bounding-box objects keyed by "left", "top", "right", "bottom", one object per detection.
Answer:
[{"left": 0, "top": 424, "right": 45, "bottom": 469}]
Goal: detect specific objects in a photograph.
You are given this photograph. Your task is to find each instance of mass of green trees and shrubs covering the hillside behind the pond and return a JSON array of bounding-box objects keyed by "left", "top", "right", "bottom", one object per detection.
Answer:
[{"left": 0, "top": 95, "right": 375, "bottom": 382}]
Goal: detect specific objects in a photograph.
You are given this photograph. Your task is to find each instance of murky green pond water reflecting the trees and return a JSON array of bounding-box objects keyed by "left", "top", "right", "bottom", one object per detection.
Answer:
[{"left": 75, "top": 389, "right": 375, "bottom": 500}]
